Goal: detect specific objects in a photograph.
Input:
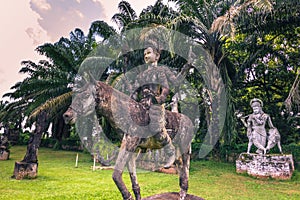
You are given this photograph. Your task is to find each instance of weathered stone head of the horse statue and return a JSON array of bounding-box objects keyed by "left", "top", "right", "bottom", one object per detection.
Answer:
[{"left": 63, "top": 82, "right": 95, "bottom": 124}]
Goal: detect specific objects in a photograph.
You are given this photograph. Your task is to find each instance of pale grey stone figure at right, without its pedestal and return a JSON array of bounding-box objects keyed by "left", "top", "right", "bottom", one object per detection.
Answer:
[{"left": 241, "top": 98, "right": 282, "bottom": 154}]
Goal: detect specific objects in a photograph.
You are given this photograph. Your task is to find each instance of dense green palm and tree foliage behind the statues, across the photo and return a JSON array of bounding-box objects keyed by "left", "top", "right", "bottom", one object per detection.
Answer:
[{"left": 0, "top": 0, "right": 300, "bottom": 158}]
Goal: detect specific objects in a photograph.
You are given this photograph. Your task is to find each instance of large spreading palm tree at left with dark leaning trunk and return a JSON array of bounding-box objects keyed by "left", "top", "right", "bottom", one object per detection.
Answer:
[{"left": 0, "top": 21, "right": 115, "bottom": 166}]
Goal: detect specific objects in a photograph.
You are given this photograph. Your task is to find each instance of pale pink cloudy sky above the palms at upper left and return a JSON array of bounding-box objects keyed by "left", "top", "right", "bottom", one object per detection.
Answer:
[{"left": 0, "top": 0, "right": 161, "bottom": 100}]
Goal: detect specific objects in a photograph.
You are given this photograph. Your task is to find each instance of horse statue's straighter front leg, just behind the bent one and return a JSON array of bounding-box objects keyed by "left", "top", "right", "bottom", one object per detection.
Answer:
[{"left": 128, "top": 156, "right": 141, "bottom": 200}]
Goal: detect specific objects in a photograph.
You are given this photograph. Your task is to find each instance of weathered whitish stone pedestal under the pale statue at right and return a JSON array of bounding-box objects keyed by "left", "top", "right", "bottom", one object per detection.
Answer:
[{"left": 236, "top": 153, "right": 295, "bottom": 180}]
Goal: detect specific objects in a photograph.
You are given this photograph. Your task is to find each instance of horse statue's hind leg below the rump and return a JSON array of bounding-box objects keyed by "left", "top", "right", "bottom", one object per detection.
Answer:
[{"left": 178, "top": 152, "right": 190, "bottom": 200}]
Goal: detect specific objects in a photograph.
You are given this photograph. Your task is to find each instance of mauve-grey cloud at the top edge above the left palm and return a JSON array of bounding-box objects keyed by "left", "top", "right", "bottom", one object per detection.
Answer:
[{"left": 30, "top": 0, "right": 104, "bottom": 41}]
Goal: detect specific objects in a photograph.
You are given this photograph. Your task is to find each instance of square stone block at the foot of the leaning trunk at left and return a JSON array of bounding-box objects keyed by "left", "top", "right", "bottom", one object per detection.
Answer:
[{"left": 12, "top": 162, "right": 38, "bottom": 180}]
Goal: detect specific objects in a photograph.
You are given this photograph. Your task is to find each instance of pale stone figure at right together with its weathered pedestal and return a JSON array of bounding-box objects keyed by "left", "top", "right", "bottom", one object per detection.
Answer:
[{"left": 236, "top": 98, "right": 295, "bottom": 180}]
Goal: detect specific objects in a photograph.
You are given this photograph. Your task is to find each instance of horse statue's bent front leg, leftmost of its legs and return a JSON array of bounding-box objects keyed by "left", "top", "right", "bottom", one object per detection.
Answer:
[{"left": 112, "top": 147, "right": 133, "bottom": 200}]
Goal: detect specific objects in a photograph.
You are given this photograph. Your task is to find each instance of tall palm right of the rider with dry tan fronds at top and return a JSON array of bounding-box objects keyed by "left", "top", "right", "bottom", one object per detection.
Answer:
[{"left": 166, "top": 0, "right": 292, "bottom": 159}]
